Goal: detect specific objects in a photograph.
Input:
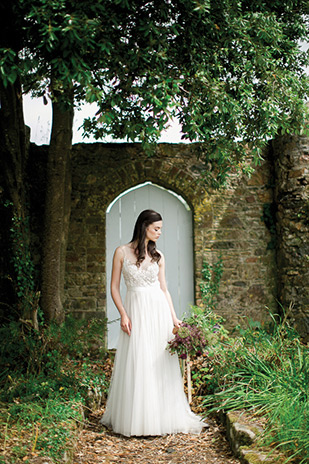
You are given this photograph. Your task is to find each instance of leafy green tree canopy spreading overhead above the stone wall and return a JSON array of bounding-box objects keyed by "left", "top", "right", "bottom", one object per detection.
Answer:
[{"left": 0, "top": 0, "right": 309, "bottom": 174}]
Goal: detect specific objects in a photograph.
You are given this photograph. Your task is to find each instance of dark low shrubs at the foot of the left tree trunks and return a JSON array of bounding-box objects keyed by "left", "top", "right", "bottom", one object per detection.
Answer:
[{"left": 0, "top": 315, "right": 106, "bottom": 385}]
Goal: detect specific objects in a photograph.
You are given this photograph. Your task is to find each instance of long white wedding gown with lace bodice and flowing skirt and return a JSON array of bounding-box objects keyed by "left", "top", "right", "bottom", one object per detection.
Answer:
[{"left": 100, "top": 247, "right": 205, "bottom": 436}]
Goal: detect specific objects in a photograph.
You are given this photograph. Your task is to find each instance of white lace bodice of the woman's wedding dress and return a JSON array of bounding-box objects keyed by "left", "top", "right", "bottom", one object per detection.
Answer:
[{"left": 122, "top": 257, "right": 159, "bottom": 288}]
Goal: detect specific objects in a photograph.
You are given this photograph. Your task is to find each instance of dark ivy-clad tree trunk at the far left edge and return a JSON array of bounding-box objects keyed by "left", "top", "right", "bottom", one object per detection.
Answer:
[{"left": 0, "top": 79, "right": 34, "bottom": 320}]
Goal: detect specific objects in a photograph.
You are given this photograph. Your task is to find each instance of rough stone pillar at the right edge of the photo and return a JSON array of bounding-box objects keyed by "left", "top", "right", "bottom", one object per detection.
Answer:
[{"left": 273, "top": 136, "right": 309, "bottom": 340}]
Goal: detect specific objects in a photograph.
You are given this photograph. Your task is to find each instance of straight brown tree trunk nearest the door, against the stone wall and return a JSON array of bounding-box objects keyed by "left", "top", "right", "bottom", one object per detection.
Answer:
[{"left": 41, "top": 87, "right": 74, "bottom": 323}]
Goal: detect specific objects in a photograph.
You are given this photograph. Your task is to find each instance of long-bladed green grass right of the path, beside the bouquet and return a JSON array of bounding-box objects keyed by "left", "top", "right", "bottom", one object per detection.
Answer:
[{"left": 192, "top": 310, "right": 309, "bottom": 463}]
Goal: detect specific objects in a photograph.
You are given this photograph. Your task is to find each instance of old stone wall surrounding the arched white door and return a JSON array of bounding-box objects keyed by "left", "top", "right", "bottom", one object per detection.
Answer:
[{"left": 65, "top": 143, "right": 277, "bottom": 326}]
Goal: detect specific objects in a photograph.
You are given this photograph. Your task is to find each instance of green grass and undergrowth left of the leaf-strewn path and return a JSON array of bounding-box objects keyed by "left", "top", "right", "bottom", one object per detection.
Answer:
[{"left": 0, "top": 318, "right": 108, "bottom": 464}]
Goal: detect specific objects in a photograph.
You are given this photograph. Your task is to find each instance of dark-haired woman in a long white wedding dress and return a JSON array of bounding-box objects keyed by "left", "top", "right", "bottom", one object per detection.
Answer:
[{"left": 101, "top": 210, "right": 206, "bottom": 436}]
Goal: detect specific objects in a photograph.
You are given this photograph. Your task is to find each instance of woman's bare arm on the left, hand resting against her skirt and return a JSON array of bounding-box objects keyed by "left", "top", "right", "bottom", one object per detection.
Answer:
[{"left": 111, "top": 247, "right": 132, "bottom": 335}]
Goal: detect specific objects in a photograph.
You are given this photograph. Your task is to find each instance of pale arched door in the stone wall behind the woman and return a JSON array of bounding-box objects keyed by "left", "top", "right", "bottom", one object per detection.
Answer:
[{"left": 106, "top": 182, "right": 194, "bottom": 349}]
